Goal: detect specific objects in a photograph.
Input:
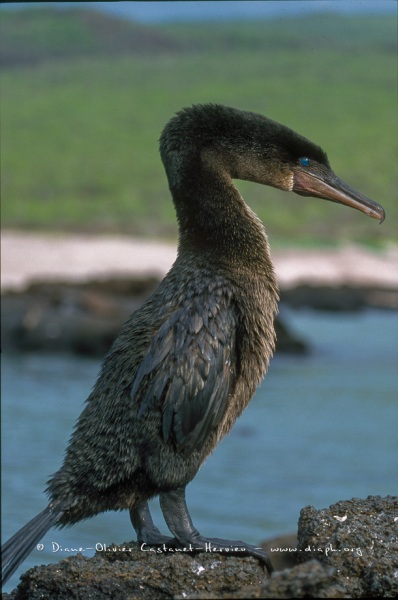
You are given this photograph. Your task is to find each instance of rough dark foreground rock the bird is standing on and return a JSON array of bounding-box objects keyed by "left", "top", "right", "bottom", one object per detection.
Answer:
[{"left": 3, "top": 496, "right": 398, "bottom": 600}]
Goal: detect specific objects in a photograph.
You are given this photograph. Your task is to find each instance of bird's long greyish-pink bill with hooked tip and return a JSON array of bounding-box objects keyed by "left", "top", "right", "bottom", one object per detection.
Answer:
[{"left": 293, "top": 170, "right": 385, "bottom": 223}]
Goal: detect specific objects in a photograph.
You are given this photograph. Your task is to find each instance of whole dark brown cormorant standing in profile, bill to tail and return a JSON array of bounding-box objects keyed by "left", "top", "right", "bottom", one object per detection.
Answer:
[{"left": 2, "top": 105, "right": 384, "bottom": 579}]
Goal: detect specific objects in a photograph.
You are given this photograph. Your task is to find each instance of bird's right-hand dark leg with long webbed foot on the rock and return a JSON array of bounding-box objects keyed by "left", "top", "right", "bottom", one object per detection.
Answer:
[{"left": 160, "top": 487, "right": 273, "bottom": 574}]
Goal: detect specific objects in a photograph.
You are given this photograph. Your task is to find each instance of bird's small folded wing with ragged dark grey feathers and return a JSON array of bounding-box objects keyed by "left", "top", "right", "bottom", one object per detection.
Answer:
[{"left": 131, "top": 297, "right": 236, "bottom": 452}]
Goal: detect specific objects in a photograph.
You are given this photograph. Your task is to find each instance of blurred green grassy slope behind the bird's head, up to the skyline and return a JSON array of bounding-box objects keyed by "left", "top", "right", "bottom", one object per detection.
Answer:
[{"left": 0, "top": 9, "right": 398, "bottom": 245}]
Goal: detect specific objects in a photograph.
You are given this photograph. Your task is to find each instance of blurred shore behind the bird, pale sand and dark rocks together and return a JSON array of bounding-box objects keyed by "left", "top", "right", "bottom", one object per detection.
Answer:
[{"left": 2, "top": 232, "right": 398, "bottom": 356}]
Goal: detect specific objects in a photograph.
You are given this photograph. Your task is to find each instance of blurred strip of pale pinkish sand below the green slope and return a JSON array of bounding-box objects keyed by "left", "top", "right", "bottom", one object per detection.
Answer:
[{"left": 1, "top": 230, "right": 398, "bottom": 292}]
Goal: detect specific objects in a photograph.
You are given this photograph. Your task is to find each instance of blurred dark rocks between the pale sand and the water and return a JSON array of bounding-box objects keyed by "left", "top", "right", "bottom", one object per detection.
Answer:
[{"left": 2, "top": 276, "right": 398, "bottom": 357}]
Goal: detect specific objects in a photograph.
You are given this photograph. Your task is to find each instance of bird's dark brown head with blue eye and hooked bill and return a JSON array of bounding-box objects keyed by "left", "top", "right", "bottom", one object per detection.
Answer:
[{"left": 160, "top": 104, "right": 385, "bottom": 222}]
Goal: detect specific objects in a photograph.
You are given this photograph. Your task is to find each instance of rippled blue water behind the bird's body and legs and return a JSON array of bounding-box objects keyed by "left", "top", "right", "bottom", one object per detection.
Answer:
[{"left": 2, "top": 311, "right": 398, "bottom": 589}]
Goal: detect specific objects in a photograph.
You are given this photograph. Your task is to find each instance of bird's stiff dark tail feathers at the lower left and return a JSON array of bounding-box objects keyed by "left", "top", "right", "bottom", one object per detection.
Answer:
[{"left": 1, "top": 504, "right": 62, "bottom": 585}]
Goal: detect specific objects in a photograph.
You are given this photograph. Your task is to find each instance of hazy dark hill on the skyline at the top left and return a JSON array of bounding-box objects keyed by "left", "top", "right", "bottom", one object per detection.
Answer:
[{"left": 0, "top": 8, "right": 178, "bottom": 68}]
